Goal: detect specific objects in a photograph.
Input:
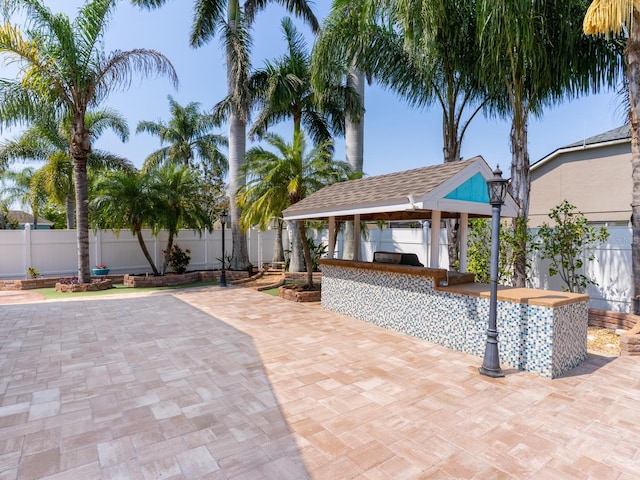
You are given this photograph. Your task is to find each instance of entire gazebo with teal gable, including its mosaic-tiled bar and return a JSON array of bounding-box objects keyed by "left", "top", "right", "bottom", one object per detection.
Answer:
[{"left": 283, "top": 157, "right": 589, "bottom": 378}]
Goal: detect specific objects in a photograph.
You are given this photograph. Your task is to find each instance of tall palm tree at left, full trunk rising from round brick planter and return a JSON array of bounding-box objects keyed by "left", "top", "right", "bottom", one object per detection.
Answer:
[{"left": 0, "top": 0, "right": 178, "bottom": 283}]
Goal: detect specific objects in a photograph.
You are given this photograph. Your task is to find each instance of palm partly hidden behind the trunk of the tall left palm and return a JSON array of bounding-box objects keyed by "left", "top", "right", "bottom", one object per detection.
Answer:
[{"left": 0, "top": 109, "right": 133, "bottom": 229}]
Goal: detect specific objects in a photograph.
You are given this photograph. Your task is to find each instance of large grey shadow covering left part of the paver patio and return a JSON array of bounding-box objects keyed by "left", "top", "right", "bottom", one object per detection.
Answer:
[{"left": 0, "top": 295, "right": 309, "bottom": 478}]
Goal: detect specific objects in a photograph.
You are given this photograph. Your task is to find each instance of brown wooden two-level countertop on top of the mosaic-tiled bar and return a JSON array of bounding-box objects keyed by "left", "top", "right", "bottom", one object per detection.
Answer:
[{"left": 320, "top": 258, "right": 589, "bottom": 308}]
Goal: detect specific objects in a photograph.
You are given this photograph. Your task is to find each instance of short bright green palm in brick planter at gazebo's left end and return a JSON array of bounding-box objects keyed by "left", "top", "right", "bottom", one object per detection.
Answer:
[{"left": 239, "top": 132, "right": 351, "bottom": 287}]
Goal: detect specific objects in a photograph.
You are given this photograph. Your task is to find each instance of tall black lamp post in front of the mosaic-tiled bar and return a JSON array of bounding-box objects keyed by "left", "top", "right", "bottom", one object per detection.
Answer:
[{"left": 479, "top": 167, "right": 509, "bottom": 378}]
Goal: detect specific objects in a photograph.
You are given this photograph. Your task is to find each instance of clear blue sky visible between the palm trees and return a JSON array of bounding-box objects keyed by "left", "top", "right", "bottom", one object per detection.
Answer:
[{"left": 1, "top": 0, "right": 624, "bottom": 176}]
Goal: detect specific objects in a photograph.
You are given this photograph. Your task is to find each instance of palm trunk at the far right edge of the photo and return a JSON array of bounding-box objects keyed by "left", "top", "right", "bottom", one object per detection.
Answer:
[{"left": 626, "top": 20, "right": 640, "bottom": 306}]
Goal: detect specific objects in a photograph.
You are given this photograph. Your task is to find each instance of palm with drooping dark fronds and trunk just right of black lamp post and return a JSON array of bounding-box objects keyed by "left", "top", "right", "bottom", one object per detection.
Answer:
[{"left": 477, "top": 0, "right": 620, "bottom": 287}]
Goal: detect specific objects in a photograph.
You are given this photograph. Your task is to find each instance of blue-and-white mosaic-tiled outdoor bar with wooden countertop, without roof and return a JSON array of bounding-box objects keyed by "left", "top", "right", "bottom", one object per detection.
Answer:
[{"left": 320, "top": 259, "right": 589, "bottom": 378}]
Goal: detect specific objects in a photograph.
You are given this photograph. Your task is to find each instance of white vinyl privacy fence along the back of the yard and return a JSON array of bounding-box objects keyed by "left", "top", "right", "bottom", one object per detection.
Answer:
[{"left": 0, "top": 222, "right": 633, "bottom": 312}]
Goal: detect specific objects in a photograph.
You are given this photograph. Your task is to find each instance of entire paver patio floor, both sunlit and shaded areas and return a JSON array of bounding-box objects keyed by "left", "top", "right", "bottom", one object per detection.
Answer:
[{"left": 0, "top": 287, "right": 640, "bottom": 480}]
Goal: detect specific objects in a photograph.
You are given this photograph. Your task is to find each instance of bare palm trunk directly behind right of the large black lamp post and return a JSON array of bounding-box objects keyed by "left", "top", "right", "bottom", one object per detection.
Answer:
[{"left": 510, "top": 95, "right": 531, "bottom": 287}]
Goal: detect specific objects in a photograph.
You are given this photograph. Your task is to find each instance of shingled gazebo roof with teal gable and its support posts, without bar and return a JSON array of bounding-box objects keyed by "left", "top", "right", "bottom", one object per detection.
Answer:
[{"left": 283, "top": 156, "right": 517, "bottom": 272}]
